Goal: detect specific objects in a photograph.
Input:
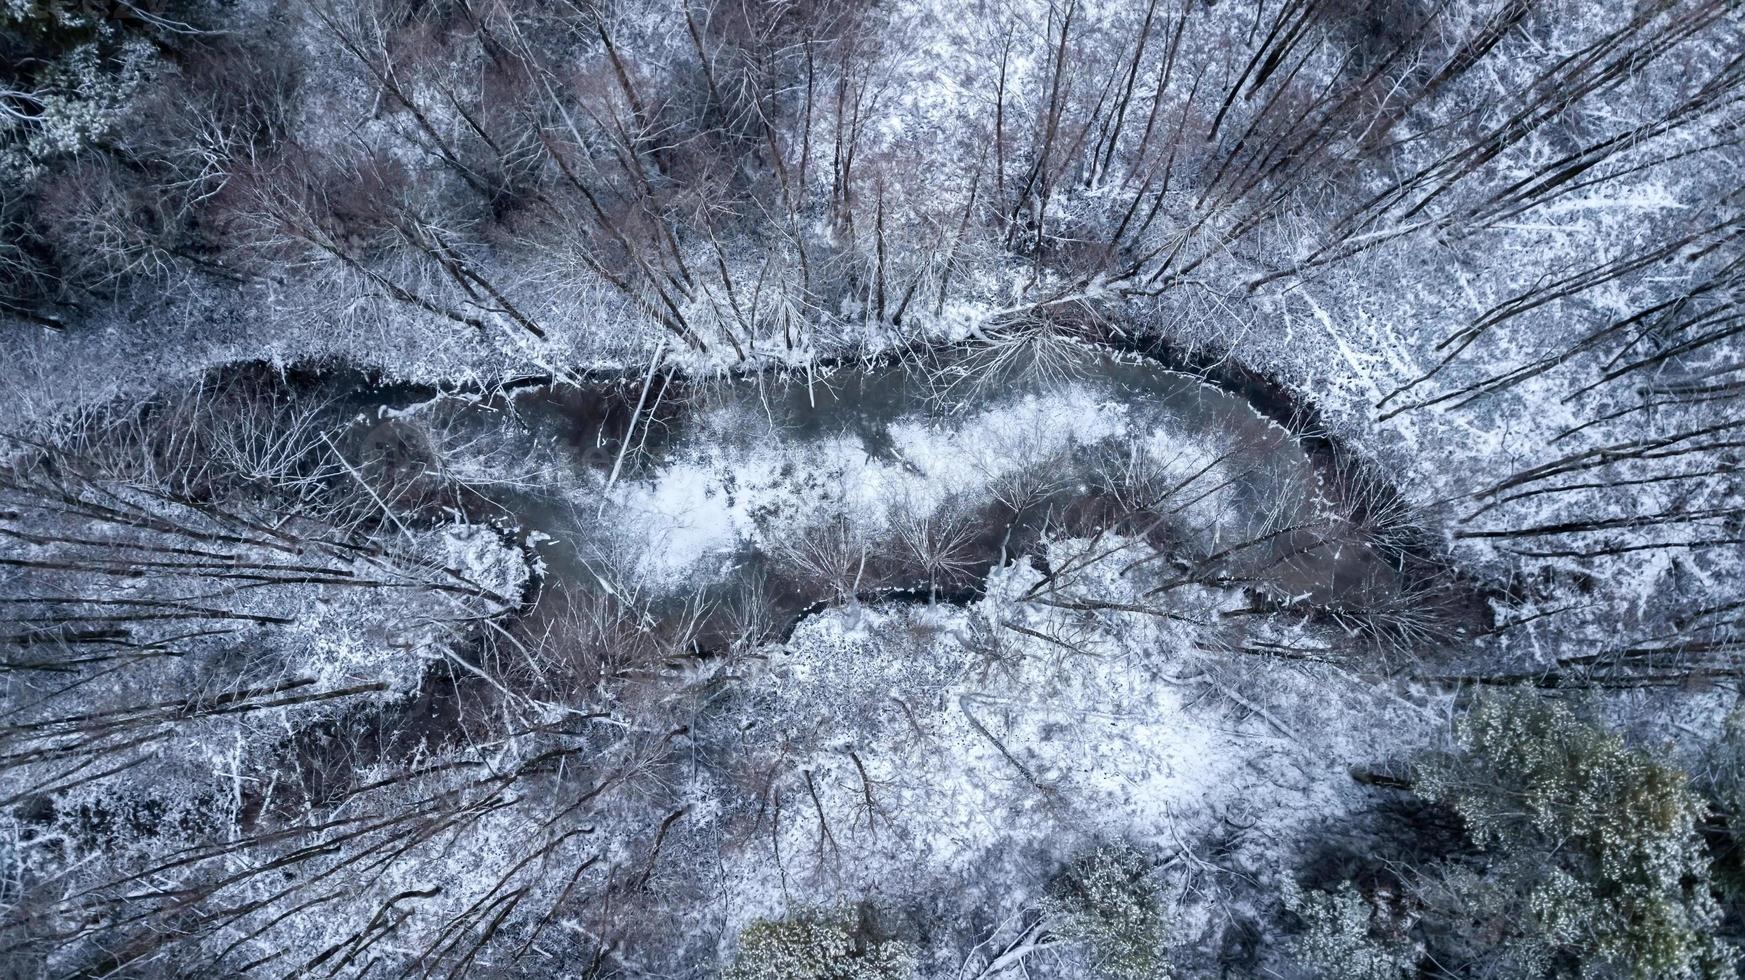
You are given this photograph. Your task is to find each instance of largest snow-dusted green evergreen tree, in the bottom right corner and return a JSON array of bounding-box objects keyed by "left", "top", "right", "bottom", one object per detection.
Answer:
[{"left": 1417, "top": 696, "right": 1735, "bottom": 980}]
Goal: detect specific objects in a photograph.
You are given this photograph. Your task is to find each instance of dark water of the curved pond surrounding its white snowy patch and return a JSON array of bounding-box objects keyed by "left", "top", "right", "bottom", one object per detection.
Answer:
[{"left": 340, "top": 340, "right": 1391, "bottom": 649}]
